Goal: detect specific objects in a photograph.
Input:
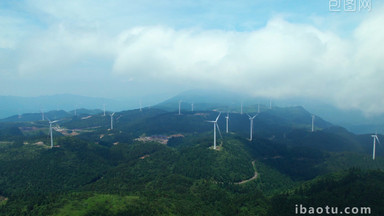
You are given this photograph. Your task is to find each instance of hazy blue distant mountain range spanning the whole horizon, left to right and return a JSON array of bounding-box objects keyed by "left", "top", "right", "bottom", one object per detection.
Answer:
[{"left": 0, "top": 90, "right": 384, "bottom": 134}]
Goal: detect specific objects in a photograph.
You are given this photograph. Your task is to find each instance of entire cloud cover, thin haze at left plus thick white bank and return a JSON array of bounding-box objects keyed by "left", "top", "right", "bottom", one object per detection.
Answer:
[{"left": 0, "top": 0, "right": 384, "bottom": 114}]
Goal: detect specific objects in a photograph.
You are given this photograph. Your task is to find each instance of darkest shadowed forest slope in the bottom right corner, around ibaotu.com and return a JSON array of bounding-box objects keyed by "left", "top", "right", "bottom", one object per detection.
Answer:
[{"left": 269, "top": 169, "right": 384, "bottom": 216}]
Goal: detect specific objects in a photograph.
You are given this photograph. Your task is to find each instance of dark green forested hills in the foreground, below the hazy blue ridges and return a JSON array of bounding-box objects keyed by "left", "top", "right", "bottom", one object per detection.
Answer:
[{"left": 0, "top": 100, "right": 384, "bottom": 215}]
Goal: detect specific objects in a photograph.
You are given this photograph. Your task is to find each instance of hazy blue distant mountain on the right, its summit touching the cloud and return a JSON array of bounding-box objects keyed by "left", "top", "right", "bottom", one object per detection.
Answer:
[{"left": 156, "top": 90, "right": 384, "bottom": 134}]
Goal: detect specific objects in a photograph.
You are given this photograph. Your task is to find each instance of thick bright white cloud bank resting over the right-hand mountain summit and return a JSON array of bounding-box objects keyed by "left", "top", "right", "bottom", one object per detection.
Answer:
[{"left": 114, "top": 15, "right": 384, "bottom": 113}]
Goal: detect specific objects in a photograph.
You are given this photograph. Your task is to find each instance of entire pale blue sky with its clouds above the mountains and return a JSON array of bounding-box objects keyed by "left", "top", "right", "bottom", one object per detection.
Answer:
[{"left": 0, "top": 0, "right": 384, "bottom": 115}]
